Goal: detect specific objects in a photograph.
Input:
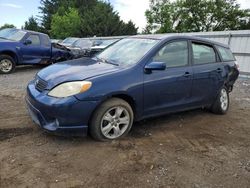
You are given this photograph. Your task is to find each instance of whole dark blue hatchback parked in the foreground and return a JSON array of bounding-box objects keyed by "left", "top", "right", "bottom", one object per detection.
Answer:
[{"left": 26, "top": 35, "right": 239, "bottom": 141}]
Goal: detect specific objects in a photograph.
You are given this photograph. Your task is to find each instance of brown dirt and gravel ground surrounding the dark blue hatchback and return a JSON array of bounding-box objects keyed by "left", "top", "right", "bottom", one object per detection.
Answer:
[{"left": 0, "top": 67, "right": 250, "bottom": 188}]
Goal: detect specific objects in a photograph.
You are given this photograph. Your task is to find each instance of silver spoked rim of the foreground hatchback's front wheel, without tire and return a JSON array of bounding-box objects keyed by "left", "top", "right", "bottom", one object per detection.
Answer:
[{"left": 101, "top": 106, "right": 130, "bottom": 139}]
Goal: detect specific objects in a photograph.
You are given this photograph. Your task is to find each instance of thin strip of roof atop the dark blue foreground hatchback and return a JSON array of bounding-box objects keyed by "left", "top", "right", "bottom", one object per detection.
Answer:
[{"left": 128, "top": 33, "right": 229, "bottom": 48}]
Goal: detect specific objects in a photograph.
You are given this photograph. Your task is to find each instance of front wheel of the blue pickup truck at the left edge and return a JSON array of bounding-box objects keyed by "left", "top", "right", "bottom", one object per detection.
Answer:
[{"left": 0, "top": 55, "right": 16, "bottom": 74}]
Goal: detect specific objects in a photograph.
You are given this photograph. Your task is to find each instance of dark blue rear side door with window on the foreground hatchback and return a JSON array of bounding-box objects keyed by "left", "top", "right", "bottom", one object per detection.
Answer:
[{"left": 192, "top": 41, "right": 223, "bottom": 106}]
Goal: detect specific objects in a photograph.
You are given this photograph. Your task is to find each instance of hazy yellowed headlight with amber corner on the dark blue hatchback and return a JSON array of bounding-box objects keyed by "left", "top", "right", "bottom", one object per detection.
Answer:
[{"left": 48, "top": 81, "right": 92, "bottom": 98}]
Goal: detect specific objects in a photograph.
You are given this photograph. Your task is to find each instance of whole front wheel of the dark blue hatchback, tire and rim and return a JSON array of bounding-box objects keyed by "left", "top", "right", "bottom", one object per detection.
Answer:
[{"left": 90, "top": 98, "right": 134, "bottom": 141}]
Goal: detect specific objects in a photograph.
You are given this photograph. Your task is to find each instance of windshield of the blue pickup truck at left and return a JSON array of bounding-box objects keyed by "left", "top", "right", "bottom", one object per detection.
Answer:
[{"left": 0, "top": 28, "right": 27, "bottom": 41}]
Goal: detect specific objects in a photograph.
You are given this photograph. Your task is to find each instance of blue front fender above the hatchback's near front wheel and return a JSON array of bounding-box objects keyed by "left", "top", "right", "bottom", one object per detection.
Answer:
[{"left": 75, "top": 66, "right": 143, "bottom": 117}]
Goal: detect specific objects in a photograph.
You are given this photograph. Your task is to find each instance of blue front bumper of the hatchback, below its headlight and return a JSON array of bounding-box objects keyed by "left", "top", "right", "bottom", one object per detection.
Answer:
[{"left": 26, "top": 83, "right": 99, "bottom": 136}]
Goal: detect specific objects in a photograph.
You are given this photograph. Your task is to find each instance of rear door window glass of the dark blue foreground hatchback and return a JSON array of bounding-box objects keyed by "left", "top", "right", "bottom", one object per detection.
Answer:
[{"left": 192, "top": 43, "right": 216, "bottom": 64}]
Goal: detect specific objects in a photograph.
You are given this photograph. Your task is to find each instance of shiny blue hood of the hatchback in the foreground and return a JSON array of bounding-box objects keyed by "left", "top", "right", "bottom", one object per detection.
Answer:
[{"left": 37, "top": 58, "right": 120, "bottom": 89}]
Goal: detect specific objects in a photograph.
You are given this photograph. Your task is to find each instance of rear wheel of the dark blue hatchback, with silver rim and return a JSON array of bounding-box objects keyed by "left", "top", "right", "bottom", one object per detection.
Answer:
[{"left": 211, "top": 87, "right": 230, "bottom": 114}]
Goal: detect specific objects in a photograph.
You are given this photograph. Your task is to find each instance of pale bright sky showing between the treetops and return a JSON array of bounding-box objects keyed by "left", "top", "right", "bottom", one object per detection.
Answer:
[{"left": 0, "top": 0, "right": 250, "bottom": 31}]
